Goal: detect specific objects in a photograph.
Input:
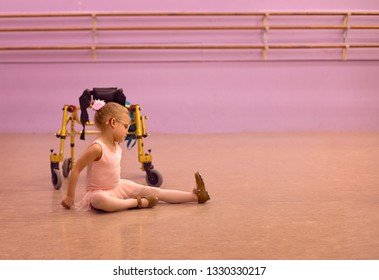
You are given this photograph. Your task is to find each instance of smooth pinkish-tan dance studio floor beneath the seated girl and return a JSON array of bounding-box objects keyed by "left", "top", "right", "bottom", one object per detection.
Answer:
[{"left": 0, "top": 132, "right": 379, "bottom": 260}]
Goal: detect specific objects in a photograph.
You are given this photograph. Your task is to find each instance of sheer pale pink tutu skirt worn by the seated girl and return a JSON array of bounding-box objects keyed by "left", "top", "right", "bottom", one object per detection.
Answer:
[{"left": 74, "top": 179, "right": 152, "bottom": 211}]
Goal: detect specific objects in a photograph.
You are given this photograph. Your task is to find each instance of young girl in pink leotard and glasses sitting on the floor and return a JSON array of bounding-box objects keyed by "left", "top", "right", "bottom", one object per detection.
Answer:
[{"left": 62, "top": 100, "right": 210, "bottom": 212}]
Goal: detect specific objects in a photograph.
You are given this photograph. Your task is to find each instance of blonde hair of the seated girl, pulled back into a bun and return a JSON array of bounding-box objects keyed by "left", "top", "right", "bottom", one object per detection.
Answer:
[{"left": 94, "top": 102, "right": 130, "bottom": 131}]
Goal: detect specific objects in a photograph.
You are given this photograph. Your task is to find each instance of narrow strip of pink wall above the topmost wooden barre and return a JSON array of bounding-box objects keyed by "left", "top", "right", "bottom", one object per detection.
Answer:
[{"left": 0, "top": 0, "right": 379, "bottom": 12}]
